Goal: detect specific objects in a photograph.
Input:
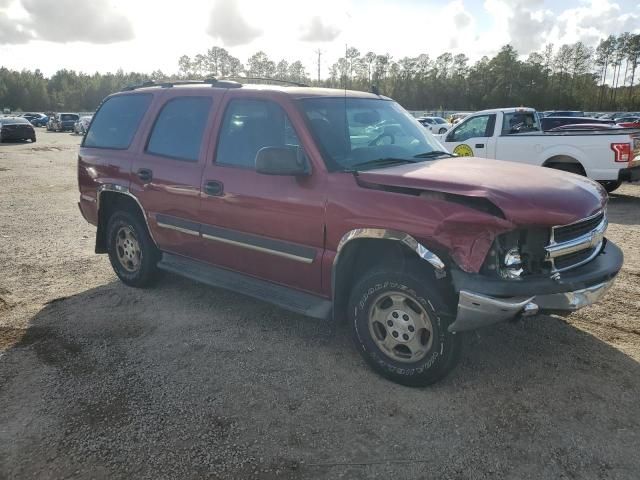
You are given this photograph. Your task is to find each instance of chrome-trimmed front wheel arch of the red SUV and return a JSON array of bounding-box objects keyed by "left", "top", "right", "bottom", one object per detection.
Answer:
[{"left": 331, "top": 228, "right": 446, "bottom": 320}]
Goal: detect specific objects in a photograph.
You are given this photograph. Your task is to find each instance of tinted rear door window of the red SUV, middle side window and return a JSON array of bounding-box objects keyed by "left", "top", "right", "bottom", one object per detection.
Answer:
[{"left": 147, "top": 97, "right": 212, "bottom": 162}]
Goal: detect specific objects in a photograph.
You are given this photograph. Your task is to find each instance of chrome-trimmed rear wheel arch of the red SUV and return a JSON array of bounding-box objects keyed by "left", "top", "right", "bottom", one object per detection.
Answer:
[{"left": 95, "top": 184, "right": 158, "bottom": 253}]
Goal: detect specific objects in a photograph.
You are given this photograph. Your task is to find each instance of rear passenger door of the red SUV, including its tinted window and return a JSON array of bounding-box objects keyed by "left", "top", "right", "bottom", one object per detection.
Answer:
[{"left": 131, "top": 89, "right": 222, "bottom": 258}]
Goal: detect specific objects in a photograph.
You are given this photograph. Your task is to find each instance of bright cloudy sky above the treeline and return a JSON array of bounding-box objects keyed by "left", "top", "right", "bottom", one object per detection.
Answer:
[{"left": 0, "top": 0, "right": 640, "bottom": 77}]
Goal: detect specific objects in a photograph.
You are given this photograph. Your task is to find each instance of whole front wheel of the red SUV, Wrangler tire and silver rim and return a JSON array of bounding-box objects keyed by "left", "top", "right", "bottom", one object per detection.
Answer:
[{"left": 349, "top": 270, "right": 462, "bottom": 387}]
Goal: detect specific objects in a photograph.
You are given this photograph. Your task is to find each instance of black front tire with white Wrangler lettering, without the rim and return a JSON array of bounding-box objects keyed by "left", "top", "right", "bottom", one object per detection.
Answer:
[{"left": 349, "top": 267, "right": 463, "bottom": 387}]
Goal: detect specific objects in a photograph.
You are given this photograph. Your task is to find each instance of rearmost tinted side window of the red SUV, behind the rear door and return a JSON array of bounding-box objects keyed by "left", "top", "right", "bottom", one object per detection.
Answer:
[{"left": 84, "top": 94, "right": 152, "bottom": 150}]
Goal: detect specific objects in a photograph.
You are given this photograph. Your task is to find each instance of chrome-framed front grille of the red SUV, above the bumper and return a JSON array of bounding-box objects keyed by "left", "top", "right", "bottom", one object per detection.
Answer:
[{"left": 545, "top": 211, "right": 607, "bottom": 272}]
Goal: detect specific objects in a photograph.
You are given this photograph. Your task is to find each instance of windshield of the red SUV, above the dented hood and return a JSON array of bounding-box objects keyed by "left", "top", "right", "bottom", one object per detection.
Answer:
[{"left": 301, "top": 97, "right": 444, "bottom": 171}]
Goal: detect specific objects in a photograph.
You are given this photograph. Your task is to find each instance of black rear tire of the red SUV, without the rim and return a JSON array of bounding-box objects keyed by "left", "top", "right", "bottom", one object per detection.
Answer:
[{"left": 107, "top": 211, "right": 160, "bottom": 288}]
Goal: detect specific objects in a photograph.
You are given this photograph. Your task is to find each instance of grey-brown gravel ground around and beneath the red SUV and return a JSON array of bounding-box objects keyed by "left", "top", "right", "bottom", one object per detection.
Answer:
[{"left": 0, "top": 129, "right": 640, "bottom": 479}]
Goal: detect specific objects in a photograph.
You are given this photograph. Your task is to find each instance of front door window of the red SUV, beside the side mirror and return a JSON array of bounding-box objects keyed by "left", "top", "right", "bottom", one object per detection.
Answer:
[{"left": 216, "top": 100, "right": 300, "bottom": 168}]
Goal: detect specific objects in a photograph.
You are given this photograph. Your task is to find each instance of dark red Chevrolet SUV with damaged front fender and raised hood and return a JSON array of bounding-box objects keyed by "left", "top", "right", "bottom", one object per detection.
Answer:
[{"left": 78, "top": 80, "right": 622, "bottom": 385}]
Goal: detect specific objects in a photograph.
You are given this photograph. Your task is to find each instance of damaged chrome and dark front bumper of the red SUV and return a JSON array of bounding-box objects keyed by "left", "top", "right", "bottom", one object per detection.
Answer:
[{"left": 449, "top": 242, "right": 623, "bottom": 332}]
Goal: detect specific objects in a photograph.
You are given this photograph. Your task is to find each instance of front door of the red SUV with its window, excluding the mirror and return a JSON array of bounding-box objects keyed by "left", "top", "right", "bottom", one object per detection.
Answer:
[{"left": 200, "top": 91, "right": 326, "bottom": 293}]
